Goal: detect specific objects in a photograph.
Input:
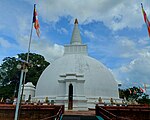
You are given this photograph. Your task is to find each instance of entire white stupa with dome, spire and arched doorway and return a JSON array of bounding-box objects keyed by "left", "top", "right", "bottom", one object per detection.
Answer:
[{"left": 35, "top": 19, "right": 119, "bottom": 110}]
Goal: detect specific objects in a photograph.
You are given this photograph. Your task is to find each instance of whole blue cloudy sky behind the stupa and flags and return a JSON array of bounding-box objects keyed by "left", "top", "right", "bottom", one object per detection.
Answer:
[{"left": 0, "top": 0, "right": 150, "bottom": 87}]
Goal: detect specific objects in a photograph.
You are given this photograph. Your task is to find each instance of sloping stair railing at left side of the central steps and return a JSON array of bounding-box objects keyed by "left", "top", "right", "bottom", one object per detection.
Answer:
[{"left": 40, "top": 106, "right": 64, "bottom": 120}]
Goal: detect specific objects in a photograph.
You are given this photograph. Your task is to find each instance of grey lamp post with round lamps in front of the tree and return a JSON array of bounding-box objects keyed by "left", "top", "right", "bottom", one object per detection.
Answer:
[{"left": 14, "top": 63, "right": 28, "bottom": 120}]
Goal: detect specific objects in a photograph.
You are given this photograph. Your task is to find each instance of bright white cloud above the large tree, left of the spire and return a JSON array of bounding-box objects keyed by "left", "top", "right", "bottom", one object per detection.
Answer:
[{"left": 18, "top": 36, "right": 64, "bottom": 62}]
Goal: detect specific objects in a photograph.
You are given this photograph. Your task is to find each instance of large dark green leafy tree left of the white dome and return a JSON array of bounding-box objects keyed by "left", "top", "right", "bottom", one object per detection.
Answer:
[{"left": 0, "top": 53, "right": 50, "bottom": 98}]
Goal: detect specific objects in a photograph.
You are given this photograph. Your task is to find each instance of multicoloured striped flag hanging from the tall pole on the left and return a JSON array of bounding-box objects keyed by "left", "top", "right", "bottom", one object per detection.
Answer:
[{"left": 33, "top": 4, "right": 40, "bottom": 37}]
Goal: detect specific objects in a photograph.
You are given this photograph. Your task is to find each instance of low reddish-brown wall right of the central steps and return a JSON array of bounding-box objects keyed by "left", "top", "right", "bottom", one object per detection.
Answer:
[{"left": 96, "top": 105, "right": 150, "bottom": 120}]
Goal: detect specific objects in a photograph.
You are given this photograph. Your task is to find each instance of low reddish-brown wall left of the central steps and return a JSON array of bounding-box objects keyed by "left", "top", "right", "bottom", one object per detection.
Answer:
[{"left": 0, "top": 104, "right": 64, "bottom": 120}]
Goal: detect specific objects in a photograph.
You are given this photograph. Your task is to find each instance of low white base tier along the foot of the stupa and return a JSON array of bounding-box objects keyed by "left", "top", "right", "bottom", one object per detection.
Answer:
[{"left": 32, "top": 95, "right": 122, "bottom": 111}]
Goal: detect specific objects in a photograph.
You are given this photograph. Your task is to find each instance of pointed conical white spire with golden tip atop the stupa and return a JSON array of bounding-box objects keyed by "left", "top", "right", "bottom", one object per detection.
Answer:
[{"left": 70, "top": 19, "right": 82, "bottom": 45}]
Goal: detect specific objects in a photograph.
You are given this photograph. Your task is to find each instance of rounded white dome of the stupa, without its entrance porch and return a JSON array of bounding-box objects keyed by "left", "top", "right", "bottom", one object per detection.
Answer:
[{"left": 36, "top": 54, "right": 118, "bottom": 97}]
